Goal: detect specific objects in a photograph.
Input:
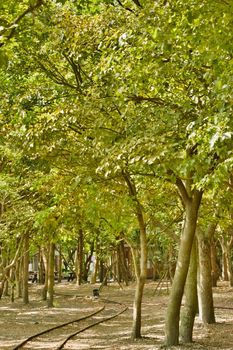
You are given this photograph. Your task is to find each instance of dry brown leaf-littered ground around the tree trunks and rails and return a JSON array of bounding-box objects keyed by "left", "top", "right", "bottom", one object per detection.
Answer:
[{"left": 0, "top": 281, "right": 233, "bottom": 350}]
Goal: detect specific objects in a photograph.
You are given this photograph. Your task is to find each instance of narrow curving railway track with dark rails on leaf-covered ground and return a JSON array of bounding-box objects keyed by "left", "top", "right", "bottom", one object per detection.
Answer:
[{"left": 12, "top": 301, "right": 127, "bottom": 350}]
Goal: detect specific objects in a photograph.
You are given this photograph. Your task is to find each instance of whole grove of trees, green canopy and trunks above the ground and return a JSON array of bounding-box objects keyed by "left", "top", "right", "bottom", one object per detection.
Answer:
[{"left": 0, "top": 0, "right": 233, "bottom": 347}]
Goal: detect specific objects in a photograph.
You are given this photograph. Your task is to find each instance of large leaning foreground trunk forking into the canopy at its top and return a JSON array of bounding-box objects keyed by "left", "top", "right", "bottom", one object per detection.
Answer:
[{"left": 165, "top": 185, "right": 202, "bottom": 346}]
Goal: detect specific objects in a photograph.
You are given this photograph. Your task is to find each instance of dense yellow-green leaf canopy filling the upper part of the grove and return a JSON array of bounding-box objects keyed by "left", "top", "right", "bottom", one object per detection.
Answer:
[{"left": 0, "top": 0, "right": 233, "bottom": 280}]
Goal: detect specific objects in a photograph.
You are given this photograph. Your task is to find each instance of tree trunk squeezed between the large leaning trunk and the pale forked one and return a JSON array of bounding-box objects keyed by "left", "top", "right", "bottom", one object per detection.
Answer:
[{"left": 180, "top": 240, "right": 198, "bottom": 343}]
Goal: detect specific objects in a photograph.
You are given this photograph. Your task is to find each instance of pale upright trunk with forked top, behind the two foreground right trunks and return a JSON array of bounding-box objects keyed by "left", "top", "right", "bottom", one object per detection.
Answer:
[{"left": 197, "top": 224, "right": 216, "bottom": 324}]
